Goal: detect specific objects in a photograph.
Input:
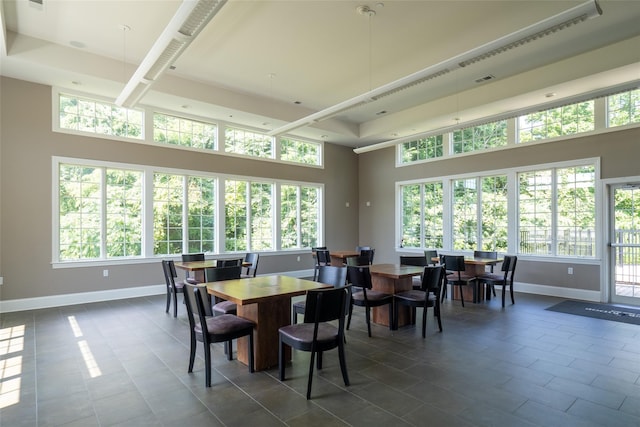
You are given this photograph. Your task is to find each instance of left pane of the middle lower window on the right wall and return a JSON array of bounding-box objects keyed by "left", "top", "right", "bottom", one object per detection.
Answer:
[{"left": 452, "top": 178, "right": 478, "bottom": 250}]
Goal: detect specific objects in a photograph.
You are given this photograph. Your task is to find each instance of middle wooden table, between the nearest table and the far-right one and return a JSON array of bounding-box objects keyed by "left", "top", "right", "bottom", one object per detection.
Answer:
[{"left": 369, "top": 264, "right": 424, "bottom": 332}]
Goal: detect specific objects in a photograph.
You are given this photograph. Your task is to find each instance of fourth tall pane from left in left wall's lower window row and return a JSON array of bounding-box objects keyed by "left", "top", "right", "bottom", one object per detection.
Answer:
[{"left": 187, "top": 176, "right": 218, "bottom": 253}]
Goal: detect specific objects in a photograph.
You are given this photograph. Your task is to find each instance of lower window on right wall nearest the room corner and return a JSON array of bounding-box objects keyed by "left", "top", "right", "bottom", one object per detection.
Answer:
[{"left": 400, "top": 182, "right": 443, "bottom": 248}]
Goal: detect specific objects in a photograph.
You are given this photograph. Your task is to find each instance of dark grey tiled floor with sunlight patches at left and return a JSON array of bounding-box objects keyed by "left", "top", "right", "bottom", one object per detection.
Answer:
[{"left": 0, "top": 294, "right": 640, "bottom": 427}]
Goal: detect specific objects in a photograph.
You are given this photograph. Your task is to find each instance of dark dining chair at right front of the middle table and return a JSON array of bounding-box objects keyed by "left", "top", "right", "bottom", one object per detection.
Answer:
[{"left": 393, "top": 266, "right": 445, "bottom": 338}]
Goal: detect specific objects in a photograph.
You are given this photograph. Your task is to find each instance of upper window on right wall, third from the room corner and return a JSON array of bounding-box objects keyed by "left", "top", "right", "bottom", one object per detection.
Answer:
[{"left": 518, "top": 101, "right": 595, "bottom": 142}]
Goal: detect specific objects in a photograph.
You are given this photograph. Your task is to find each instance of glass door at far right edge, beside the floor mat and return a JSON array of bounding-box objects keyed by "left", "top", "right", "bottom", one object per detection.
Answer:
[{"left": 609, "top": 183, "right": 640, "bottom": 305}]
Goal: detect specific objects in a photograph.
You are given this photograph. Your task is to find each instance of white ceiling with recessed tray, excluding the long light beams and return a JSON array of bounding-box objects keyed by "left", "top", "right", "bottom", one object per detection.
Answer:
[{"left": 0, "top": 0, "right": 640, "bottom": 147}]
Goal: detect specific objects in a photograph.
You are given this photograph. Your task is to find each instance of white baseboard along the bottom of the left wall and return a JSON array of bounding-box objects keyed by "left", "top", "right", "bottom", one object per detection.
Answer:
[{"left": 0, "top": 270, "right": 313, "bottom": 313}]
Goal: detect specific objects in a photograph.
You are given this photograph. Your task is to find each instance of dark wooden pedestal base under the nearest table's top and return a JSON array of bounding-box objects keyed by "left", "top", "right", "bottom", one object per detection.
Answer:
[{"left": 237, "top": 298, "right": 291, "bottom": 371}]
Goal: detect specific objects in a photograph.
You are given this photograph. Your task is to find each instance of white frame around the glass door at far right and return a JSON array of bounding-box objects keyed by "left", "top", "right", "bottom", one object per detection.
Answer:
[{"left": 600, "top": 175, "right": 640, "bottom": 302}]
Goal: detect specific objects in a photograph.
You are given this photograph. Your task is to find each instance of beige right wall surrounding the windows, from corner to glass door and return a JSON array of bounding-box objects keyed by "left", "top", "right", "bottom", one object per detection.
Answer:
[{"left": 359, "top": 123, "right": 640, "bottom": 291}]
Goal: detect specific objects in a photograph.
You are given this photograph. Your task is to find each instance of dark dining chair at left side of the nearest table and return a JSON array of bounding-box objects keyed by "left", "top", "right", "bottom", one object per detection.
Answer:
[{"left": 185, "top": 283, "right": 255, "bottom": 387}]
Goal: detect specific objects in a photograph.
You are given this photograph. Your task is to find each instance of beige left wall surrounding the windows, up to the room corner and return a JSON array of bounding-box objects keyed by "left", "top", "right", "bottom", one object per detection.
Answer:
[{"left": 0, "top": 78, "right": 358, "bottom": 301}]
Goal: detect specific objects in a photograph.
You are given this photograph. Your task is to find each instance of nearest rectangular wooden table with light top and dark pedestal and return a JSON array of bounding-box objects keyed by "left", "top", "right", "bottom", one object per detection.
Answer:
[{"left": 206, "top": 276, "right": 332, "bottom": 370}]
